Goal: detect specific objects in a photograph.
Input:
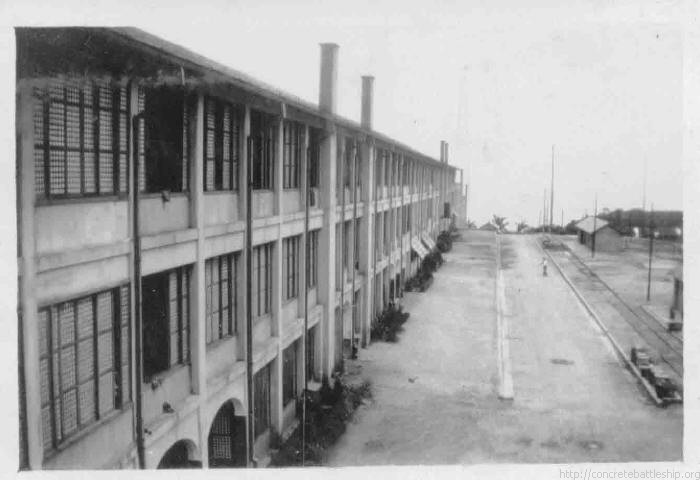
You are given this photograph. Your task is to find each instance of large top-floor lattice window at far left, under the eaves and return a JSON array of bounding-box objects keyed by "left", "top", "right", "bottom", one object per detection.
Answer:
[{"left": 33, "top": 80, "right": 129, "bottom": 198}]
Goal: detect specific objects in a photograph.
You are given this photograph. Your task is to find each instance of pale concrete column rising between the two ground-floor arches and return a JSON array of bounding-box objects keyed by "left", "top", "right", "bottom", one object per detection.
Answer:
[{"left": 187, "top": 93, "right": 209, "bottom": 468}]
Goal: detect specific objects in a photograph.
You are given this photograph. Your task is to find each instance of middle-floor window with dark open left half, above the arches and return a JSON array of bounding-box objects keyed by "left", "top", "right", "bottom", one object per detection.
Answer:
[{"left": 141, "top": 267, "right": 190, "bottom": 381}]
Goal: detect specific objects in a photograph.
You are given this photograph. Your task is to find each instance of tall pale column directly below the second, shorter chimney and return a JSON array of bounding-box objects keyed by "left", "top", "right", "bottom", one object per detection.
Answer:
[{"left": 359, "top": 137, "right": 377, "bottom": 347}]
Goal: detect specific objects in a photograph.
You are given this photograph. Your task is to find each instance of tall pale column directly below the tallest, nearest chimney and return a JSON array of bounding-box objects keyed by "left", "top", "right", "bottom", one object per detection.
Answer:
[{"left": 318, "top": 125, "right": 338, "bottom": 375}]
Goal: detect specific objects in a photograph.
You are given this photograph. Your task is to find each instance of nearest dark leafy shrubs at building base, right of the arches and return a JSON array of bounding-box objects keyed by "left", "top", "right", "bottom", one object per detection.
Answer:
[{"left": 270, "top": 378, "right": 372, "bottom": 467}]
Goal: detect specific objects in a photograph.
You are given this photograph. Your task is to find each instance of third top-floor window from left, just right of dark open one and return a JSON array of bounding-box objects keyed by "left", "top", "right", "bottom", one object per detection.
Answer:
[{"left": 204, "top": 97, "right": 242, "bottom": 191}]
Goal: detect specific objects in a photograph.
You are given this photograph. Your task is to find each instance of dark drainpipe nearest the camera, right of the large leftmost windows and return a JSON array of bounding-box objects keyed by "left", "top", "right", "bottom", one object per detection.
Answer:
[{"left": 133, "top": 109, "right": 146, "bottom": 469}]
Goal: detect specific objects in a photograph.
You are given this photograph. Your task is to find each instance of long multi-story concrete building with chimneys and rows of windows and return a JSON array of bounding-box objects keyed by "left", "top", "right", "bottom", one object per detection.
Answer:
[{"left": 16, "top": 28, "right": 465, "bottom": 469}]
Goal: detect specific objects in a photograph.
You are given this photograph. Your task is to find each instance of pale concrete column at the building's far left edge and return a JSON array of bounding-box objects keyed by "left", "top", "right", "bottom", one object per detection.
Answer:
[{"left": 16, "top": 82, "right": 44, "bottom": 470}]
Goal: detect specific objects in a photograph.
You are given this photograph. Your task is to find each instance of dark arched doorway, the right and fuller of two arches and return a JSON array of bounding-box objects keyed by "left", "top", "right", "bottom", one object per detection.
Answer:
[{"left": 207, "top": 400, "right": 246, "bottom": 468}]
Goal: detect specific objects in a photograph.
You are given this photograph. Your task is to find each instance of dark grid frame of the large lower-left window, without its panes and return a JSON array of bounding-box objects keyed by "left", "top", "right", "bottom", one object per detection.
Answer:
[{"left": 38, "top": 284, "right": 132, "bottom": 457}]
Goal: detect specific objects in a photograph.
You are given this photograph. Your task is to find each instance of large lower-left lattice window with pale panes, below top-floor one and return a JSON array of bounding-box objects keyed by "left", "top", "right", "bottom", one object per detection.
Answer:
[{"left": 38, "top": 285, "right": 131, "bottom": 451}]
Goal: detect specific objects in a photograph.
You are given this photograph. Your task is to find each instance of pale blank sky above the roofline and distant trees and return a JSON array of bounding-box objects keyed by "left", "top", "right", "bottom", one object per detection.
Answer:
[{"left": 2, "top": 0, "right": 683, "bottom": 225}]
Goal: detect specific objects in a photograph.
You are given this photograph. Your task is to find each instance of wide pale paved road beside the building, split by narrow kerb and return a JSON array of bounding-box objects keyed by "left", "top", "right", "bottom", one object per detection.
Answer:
[{"left": 327, "top": 232, "right": 682, "bottom": 466}]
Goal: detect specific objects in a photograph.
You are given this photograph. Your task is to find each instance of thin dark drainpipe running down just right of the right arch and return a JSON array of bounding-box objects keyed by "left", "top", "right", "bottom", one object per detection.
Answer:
[{"left": 245, "top": 135, "right": 255, "bottom": 466}]
